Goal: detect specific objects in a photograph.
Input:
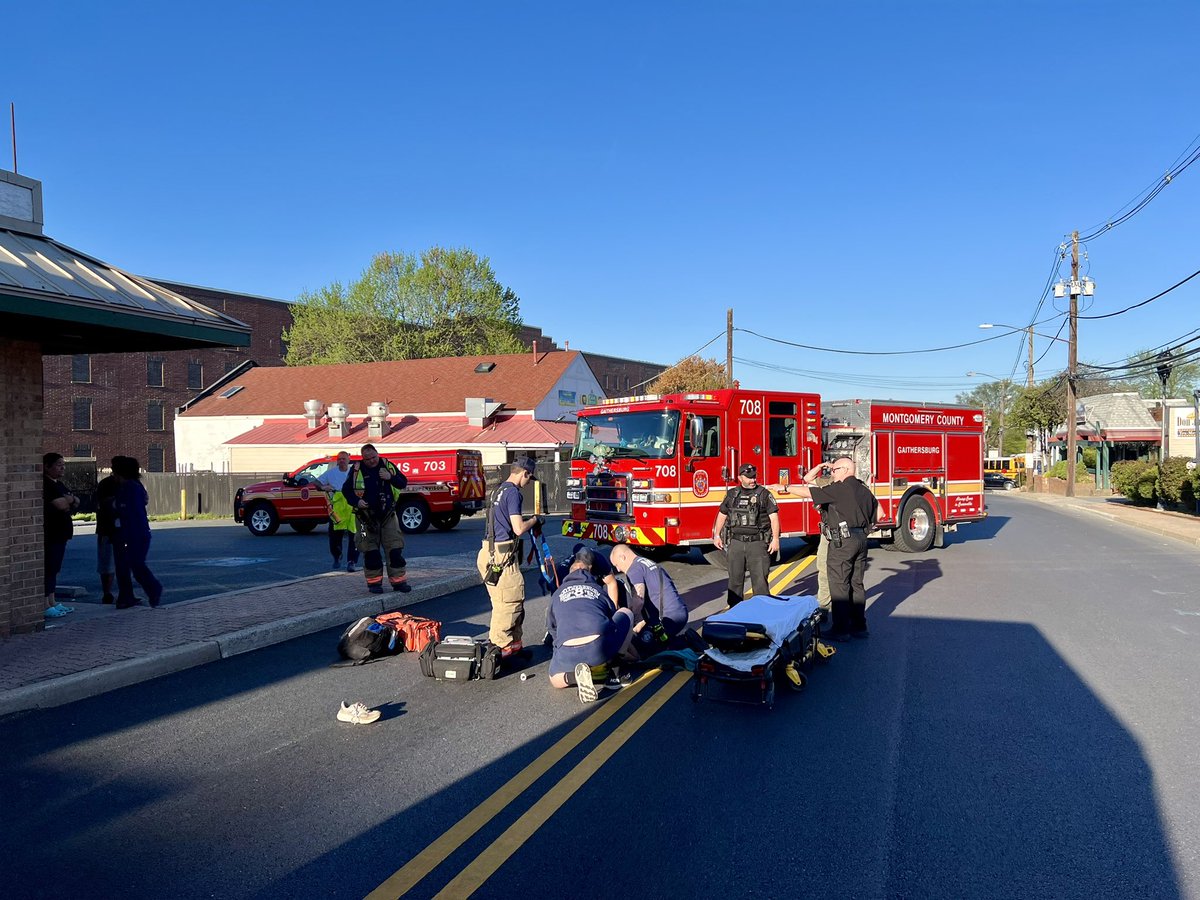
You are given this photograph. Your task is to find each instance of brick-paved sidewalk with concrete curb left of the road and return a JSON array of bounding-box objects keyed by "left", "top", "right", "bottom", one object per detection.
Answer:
[{"left": 0, "top": 564, "right": 479, "bottom": 715}]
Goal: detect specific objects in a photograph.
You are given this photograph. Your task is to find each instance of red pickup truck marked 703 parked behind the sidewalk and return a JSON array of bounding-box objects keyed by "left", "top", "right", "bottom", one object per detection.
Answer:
[{"left": 233, "top": 450, "right": 487, "bottom": 538}]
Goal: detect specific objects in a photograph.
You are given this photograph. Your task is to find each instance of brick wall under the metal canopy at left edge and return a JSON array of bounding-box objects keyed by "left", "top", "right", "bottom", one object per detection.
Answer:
[{"left": 0, "top": 338, "right": 46, "bottom": 637}]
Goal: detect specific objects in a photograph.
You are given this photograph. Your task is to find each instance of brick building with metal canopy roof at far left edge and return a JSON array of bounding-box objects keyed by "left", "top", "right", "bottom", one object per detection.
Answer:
[{"left": 0, "top": 172, "right": 250, "bottom": 637}]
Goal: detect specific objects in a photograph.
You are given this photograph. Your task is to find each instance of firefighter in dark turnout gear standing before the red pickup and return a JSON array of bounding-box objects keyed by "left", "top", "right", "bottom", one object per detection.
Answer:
[{"left": 342, "top": 444, "right": 413, "bottom": 594}]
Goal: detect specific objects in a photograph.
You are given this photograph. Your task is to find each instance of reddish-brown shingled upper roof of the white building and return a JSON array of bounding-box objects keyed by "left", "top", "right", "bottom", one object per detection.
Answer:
[{"left": 182, "top": 350, "right": 587, "bottom": 427}]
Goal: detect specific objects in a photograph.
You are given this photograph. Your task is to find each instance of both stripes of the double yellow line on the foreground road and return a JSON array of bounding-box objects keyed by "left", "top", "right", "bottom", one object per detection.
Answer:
[{"left": 367, "top": 668, "right": 691, "bottom": 900}]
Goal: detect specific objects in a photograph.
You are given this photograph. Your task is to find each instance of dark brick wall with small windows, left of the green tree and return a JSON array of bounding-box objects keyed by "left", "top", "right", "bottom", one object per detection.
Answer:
[{"left": 42, "top": 289, "right": 292, "bottom": 472}]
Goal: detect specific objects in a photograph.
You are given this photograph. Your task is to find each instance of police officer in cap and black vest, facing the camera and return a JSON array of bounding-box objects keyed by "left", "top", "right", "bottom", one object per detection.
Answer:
[{"left": 713, "top": 463, "right": 779, "bottom": 606}]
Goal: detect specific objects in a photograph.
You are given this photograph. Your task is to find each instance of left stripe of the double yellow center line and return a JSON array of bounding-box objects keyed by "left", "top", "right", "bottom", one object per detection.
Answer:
[{"left": 367, "top": 668, "right": 662, "bottom": 900}]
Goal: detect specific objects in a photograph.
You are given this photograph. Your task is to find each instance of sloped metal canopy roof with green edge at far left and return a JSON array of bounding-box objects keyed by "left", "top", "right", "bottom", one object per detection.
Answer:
[{"left": 0, "top": 172, "right": 250, "bottom": 355}]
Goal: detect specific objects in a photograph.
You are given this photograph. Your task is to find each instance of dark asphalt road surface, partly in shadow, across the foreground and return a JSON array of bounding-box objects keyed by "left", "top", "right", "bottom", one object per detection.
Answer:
[{"left": 0, "top": 496, "right": 1200, "bottom": 899}]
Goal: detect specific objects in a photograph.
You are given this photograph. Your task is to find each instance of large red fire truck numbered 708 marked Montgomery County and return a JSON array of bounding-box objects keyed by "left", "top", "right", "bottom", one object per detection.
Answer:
[{"left": 563, "top": 389, "right": 986, "bottom": 554}]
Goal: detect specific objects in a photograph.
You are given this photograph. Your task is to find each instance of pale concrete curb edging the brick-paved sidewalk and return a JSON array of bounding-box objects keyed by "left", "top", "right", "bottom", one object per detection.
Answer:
[{"left": 0, "top": 572, "right": 480, "bottom": 716}]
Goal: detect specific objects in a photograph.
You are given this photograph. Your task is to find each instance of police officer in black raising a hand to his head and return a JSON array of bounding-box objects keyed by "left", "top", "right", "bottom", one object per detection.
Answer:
[{"left": 776, "top": 456, "right": 878, "bottom": 641}]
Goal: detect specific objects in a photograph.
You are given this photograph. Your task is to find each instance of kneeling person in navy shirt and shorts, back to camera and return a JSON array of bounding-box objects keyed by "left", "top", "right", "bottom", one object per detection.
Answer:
[{"left": 546, "top": 554, "right": 634, "bottom": 702}]
